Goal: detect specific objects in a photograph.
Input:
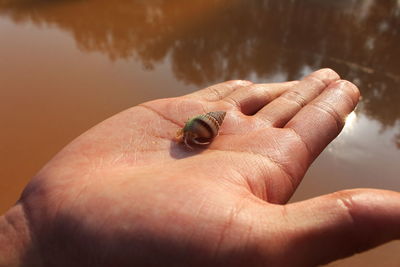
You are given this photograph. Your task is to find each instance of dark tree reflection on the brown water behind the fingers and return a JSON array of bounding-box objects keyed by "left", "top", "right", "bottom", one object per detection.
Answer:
[{"left": 0, "top": 0, "right": 400, "bottom": 143}]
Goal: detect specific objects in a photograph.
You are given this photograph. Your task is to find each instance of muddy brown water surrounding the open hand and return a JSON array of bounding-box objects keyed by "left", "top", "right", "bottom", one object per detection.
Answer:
[{"left": 0, "top": 0, "right": 400, "bottom": 266}]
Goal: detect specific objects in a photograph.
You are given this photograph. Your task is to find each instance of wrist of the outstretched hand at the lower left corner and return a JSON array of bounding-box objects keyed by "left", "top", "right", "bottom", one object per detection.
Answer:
[{"left": 0, "top": 204, "right": 40, "bottom": 266}]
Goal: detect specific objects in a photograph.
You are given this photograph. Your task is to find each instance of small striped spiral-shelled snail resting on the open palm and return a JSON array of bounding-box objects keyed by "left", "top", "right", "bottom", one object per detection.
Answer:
[{"left": 176, "top": 111, "right": 226, "bottom": 148}]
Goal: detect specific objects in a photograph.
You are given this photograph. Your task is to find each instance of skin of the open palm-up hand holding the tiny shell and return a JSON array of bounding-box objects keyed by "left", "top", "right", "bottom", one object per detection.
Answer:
[{"left": 0, "top": 69, "right": 400, "bottom": 266}]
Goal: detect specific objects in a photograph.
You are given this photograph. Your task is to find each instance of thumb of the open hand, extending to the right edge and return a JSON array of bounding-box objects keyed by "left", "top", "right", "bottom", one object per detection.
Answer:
[{"left": 284, "top": 189, "right": 400, "bottom": 266}]
